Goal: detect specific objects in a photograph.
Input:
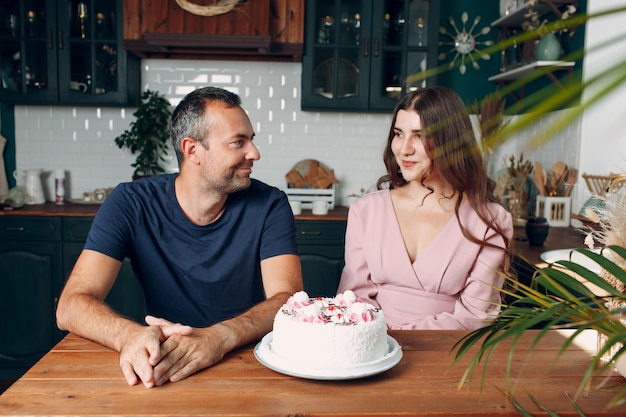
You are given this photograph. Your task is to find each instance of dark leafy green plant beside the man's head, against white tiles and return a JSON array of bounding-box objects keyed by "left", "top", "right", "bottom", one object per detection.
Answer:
[{"left": 115, "top": 90, "right": 172, "bottom": 179}]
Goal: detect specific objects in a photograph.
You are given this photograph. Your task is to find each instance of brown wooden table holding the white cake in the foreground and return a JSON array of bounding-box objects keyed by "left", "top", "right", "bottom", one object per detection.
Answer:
[{"left": 0, "top": 331, "right": 626, "bottom": 417}]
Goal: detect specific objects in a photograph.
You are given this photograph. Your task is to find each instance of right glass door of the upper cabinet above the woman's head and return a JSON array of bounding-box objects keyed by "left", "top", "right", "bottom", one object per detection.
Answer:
[{"left": 370, "top": 0, "right": 438, "bottom": 109}]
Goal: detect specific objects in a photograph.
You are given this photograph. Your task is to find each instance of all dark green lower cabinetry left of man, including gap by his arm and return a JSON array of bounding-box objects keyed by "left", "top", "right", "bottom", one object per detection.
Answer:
[{"left": 0, "top": 215, "right": 145, "bottom": 379}]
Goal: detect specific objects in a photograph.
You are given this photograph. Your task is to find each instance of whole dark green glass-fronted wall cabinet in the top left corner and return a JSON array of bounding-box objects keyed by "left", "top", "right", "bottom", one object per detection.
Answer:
[{"left": 0, "top": 0, "right": 141, "bottom": 106}]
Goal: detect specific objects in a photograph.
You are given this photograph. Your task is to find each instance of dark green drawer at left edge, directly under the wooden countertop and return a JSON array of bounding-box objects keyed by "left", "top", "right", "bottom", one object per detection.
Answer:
[{"left": 0, "top": 216, "right": 62, "bottom": 241}]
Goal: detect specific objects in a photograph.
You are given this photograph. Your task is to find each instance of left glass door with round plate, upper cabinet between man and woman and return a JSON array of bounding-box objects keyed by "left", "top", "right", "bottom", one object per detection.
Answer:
[{"left": 302, "top": 0, "right": 370, "bottom": 108}]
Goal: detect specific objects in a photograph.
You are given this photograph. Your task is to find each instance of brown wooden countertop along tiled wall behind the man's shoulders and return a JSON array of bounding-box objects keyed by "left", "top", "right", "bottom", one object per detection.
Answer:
[{"left": 0, "top": 202, "right": 348, "bottom": 221}]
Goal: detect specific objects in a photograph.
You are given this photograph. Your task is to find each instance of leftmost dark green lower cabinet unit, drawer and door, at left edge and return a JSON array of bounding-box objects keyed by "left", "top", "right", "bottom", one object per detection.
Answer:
[{"left": 0, "top": 216, "right": 63, "bottom": 378}]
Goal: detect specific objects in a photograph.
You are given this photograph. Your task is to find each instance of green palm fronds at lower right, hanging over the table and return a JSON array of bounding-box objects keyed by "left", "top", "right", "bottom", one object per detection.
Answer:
[{"left": 453, "top": 246, "right": 626, "bottom": 411}]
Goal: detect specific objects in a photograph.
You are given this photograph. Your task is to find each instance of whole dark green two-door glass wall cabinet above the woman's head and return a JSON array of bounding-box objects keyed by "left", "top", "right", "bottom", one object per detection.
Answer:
[{"left": 301, "top": 0, "right": 439, "bottom": 111}]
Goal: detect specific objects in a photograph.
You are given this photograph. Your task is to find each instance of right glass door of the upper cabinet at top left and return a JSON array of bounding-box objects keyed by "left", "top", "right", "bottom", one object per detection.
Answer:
[{"left": 58, "top": 0, "right": 121, "bottom": 102}]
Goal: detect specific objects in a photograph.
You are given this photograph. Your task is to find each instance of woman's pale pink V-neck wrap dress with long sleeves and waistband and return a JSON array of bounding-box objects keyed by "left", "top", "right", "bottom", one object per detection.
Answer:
[{"left": 338, "top": 190, "right": 513, "bottom": 330}]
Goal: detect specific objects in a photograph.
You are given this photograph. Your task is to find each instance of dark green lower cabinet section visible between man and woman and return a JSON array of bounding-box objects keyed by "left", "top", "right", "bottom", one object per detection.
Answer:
[{"left": 296, "top": 220, "right": 346, "bottom": 297}]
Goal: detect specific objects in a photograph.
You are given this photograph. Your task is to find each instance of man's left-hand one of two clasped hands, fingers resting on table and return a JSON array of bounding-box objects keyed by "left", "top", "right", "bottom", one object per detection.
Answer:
[{"left": 120, "top": 316, "right": 193, "bottom": 388}]
